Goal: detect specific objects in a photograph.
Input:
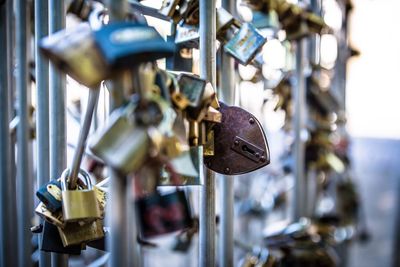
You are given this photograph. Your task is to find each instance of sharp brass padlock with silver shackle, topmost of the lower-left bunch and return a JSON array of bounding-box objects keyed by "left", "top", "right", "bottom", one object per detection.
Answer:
[{"left": 61, "top": 169, "right": 101, "bottom": 222}]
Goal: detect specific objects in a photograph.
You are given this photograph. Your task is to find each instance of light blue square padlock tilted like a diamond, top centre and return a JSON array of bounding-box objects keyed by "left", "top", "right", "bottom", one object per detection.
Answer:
[{"left": 224, "top": 23, "right": 267, "bottom": 65}]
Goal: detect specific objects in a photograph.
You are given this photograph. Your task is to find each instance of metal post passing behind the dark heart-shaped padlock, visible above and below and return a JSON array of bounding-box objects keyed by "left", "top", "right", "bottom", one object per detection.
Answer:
[{"left": 218, "top": 0, "right": 235, "bottom": 267}]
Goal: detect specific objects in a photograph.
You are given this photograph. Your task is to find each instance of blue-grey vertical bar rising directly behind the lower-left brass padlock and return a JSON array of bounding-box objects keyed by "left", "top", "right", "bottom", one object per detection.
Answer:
[{"left": 48, "top": 0, "right": 68, "bottom": 267}]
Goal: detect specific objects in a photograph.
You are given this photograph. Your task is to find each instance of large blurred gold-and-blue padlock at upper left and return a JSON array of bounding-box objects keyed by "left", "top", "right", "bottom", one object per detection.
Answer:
[{"left": 40, "top": 22, "right": 175, "bottom": 88}]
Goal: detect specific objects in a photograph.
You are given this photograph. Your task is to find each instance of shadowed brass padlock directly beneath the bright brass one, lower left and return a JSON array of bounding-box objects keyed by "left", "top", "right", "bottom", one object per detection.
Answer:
[{"left": 57, "top": 220, "right": 104, "bottom": 247}]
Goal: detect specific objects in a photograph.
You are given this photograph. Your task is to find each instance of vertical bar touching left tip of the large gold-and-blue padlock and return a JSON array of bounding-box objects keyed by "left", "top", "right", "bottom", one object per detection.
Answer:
[{"left": 35, "top": 0, "right": 51, "bottom": 267}]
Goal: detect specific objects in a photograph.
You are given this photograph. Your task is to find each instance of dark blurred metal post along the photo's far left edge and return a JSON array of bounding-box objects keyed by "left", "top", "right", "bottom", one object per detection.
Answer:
[{"left": 0, "top": 3, "right": 18, "bottom": 266}]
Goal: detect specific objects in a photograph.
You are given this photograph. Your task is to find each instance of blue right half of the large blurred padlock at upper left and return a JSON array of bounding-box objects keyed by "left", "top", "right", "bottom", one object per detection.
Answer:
[{"left": 93, "top": 22, "right": 175, "bottom": 69}]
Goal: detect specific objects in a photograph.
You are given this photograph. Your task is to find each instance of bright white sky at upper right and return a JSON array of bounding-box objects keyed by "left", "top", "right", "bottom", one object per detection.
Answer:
[{"left": 347, "top": 0, "right": 400, "bottom": 139}]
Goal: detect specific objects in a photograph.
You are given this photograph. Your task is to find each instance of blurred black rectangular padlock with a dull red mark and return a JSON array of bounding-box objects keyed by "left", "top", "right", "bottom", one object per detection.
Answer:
[{"left": 135, "top": 190, "right": 192, "bottom": 238}]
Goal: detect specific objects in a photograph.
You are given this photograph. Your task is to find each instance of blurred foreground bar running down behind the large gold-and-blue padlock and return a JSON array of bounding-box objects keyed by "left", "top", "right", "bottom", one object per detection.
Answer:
[{"left": 106, "top": 0, "right": 133, "bottom": 267}]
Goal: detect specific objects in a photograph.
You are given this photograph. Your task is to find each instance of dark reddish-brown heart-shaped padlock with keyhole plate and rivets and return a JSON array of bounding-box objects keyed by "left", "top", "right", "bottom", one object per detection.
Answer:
[{"left": 204, "top": 102, "right": 270, "bottom": 175}]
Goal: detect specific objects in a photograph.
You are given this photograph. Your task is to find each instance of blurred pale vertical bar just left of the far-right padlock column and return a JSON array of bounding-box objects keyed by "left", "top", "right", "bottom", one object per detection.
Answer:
[{"left": 293, "top": 38, "right": 308, "bottom": 220}]
